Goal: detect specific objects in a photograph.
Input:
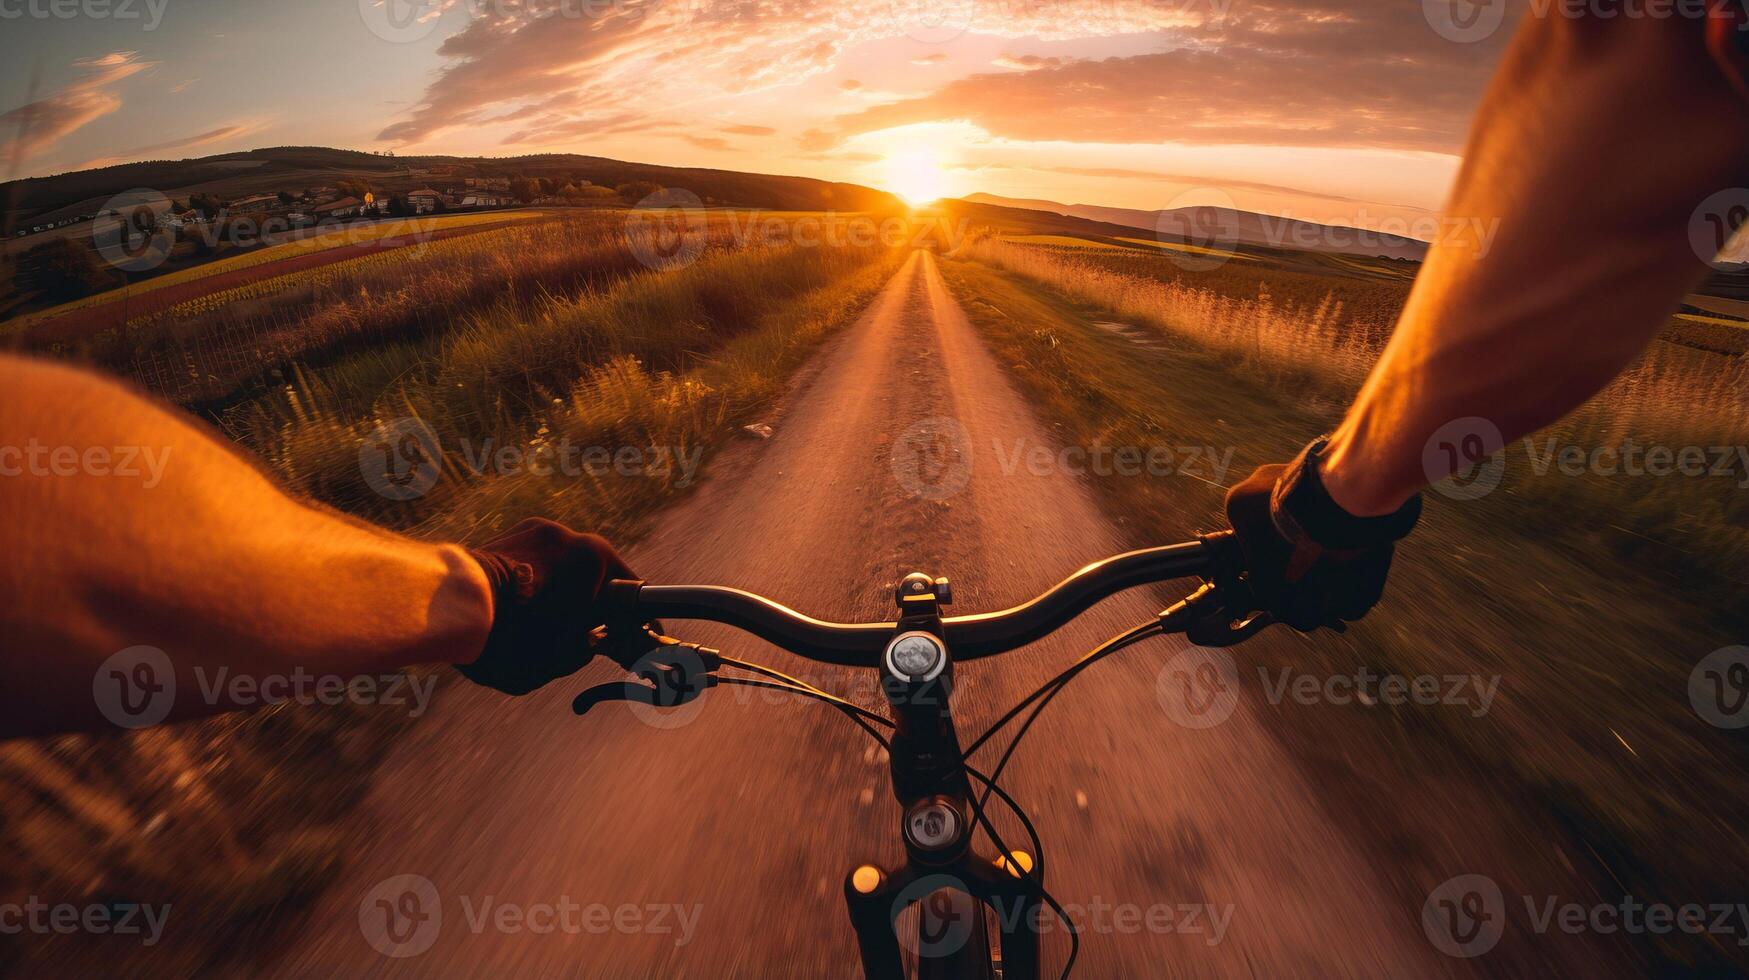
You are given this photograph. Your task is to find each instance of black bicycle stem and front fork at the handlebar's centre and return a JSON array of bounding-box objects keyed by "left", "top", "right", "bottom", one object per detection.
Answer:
[{"left": 845, "top": 572, "right": 1042, "bottom": 980}]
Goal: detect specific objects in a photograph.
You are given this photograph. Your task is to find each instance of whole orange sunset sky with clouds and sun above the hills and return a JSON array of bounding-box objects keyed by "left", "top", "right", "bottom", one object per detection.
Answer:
[{"left": 0, "top": 0, "right": 1509, "bottom": 229}]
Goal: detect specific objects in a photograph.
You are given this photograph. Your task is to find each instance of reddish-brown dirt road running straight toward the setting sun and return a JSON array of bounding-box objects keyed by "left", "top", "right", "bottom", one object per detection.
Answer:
[{"left": 265, "top": 252, "right": 1459, "bottom": 978}]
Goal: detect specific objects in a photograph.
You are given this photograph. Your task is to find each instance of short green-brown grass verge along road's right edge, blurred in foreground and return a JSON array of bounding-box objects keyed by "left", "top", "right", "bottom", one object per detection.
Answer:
[{"left": 943, "top": 252, "right": 1749, "bottom": 973}]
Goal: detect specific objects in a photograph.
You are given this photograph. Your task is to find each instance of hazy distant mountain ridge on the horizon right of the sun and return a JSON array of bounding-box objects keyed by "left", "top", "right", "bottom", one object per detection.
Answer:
[{"left": 962, "top": 193, "right": 1427, "bottom": 261}]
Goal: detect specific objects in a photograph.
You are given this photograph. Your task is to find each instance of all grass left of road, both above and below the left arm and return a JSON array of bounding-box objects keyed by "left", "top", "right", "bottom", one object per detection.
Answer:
[{"left": 0, "top": 236, "right": 904, "bottom": 977}]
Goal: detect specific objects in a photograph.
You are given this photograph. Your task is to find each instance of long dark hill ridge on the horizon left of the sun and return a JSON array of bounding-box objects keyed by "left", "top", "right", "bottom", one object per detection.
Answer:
[{"left": 0, "top": 147, "right": 904, "bottom": 222}]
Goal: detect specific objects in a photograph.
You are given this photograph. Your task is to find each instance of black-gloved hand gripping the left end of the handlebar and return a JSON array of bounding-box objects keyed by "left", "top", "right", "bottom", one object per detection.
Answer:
[{"left": 456, "top": 518, "right": 637, "bottom": 695}]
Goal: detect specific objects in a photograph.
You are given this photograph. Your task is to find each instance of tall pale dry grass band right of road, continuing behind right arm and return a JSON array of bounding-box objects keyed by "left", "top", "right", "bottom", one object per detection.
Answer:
[{"left": 958, "top": 236, "right": 1749, "bottom": 604}]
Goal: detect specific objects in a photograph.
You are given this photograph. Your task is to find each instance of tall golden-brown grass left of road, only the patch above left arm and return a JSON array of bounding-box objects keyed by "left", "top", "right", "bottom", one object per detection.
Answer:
[{"left": 243, "top": 238, "right": 892, "bottom": 529}]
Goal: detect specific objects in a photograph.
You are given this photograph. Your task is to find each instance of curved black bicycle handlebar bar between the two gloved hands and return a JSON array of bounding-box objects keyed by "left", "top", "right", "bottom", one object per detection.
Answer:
[{"left": 614, "top": 536, "right": 1224, "bottom": 667}]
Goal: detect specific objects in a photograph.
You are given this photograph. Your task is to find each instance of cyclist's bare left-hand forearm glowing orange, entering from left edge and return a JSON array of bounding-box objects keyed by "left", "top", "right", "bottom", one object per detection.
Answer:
[{"left": 0, "top": 357, "right": 491, "bottom": 737}]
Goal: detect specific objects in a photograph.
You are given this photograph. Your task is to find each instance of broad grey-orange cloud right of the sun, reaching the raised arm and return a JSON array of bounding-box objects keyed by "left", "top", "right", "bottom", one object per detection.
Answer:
[{"left": 836, "top": 0, "right": 1511, "bottom": 152}]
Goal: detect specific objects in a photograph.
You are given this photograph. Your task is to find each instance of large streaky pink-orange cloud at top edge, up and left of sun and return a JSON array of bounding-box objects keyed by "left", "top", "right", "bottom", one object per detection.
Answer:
[{"left": 380, "top": 0, "right": 1202, "bottom": 144}]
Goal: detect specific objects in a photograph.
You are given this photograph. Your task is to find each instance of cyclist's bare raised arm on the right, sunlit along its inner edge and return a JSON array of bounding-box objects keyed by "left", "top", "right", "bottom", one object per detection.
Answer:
[{"left": 1322, "top": 12, "right": 1749, "bottom": 515}]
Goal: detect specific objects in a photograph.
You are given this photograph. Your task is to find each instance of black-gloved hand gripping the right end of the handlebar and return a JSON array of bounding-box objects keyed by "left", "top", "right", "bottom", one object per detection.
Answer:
[{"left": 1226, "top": 438, "right": 1420, "bottom": 634}]
